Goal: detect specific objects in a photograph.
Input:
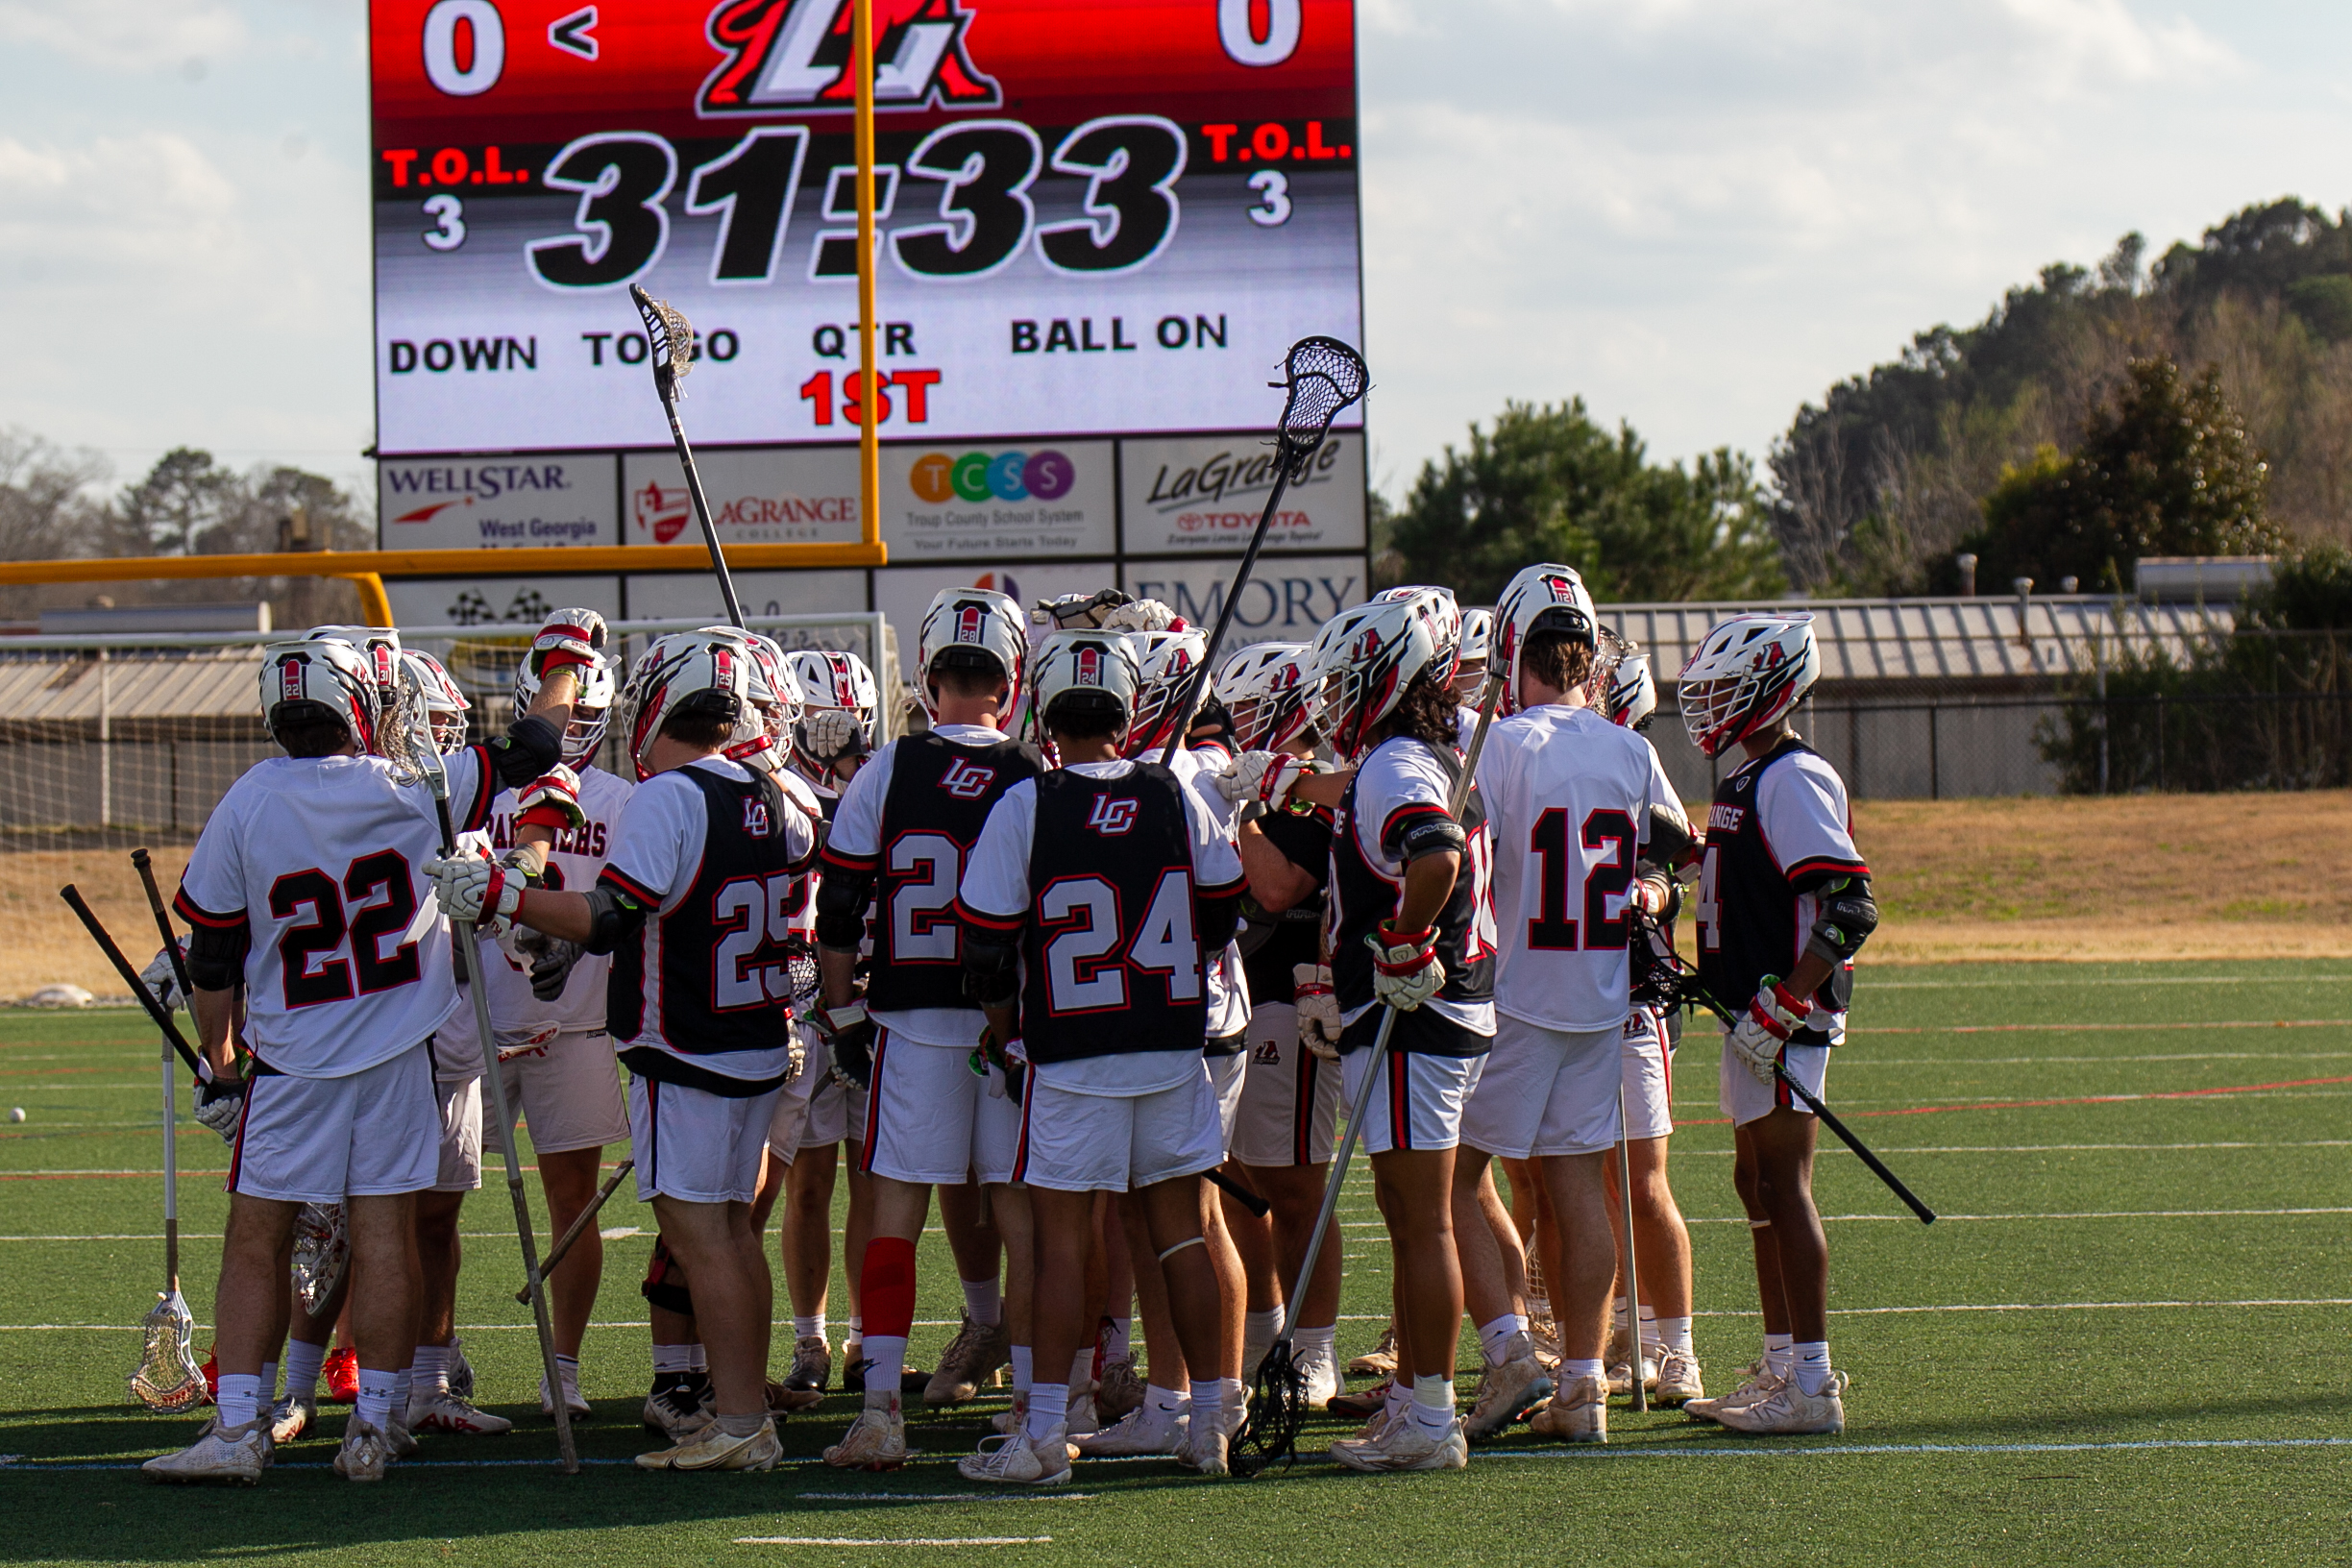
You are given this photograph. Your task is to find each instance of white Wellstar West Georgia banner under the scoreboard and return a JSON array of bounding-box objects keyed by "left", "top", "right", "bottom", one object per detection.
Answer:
[{"left": 377, "top": 453, "right": 621, "bottom": 551}]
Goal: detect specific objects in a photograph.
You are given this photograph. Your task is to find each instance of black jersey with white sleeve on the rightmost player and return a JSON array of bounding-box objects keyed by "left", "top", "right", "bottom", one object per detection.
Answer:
[{"left": 1694, "top": 736, "right": 1870, "bottom": 1046}]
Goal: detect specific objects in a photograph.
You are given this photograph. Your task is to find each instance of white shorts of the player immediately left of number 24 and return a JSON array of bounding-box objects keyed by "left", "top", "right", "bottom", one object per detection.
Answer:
[{"left": 859, "top": 1030, "right": 1020, "bottom": 1188}]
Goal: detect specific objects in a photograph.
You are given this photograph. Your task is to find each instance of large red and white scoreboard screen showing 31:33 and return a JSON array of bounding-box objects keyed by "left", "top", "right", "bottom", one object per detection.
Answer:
[{"left": 372, "top": 0, "right": 1361, "bottom": 453}]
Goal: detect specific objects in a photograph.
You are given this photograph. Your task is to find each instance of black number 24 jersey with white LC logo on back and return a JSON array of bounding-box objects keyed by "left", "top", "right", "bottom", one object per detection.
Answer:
[{"left": 1020, "top": 762, "right": 1209, "bottom": 1063}]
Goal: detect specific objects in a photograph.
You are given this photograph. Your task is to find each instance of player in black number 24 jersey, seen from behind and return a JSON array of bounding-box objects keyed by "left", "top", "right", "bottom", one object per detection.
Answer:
[{"left": 957, "top": 632, "right": 1242, "bottom": 1485}]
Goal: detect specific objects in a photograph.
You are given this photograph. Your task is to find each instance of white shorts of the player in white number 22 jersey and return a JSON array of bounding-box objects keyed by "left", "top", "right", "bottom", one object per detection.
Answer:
[{"left": 226, "top": 1041, "right": 440, "bottom": 1204}]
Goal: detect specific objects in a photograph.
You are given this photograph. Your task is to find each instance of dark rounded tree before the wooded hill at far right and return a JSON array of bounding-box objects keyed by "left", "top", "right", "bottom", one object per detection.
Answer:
[{"left": 1967, "top": 355, "right": 2286, "bottom": 588}]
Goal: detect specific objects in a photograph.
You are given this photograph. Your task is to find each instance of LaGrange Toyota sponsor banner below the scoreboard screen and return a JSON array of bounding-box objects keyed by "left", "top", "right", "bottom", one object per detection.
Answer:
[{"left": 1119, "top": 430, "right": 1364, "bottom": 554}]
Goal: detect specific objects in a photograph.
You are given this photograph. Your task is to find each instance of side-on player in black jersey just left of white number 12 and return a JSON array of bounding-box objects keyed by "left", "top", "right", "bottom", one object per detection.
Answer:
[{"left": 1308, "top": 593, "right": 1493, "bottom": 1472}]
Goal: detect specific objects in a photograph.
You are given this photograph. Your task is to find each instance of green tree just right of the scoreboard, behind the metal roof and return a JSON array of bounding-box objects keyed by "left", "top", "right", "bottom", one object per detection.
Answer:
[{"left": 1390, "top": 398, "right": 1785, "bottom": 604}]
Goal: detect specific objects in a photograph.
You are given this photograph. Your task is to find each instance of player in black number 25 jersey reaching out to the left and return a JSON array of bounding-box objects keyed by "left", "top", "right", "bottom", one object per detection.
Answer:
[{"left": 432, "top": 630, "right": 816, "bottom": 1469}]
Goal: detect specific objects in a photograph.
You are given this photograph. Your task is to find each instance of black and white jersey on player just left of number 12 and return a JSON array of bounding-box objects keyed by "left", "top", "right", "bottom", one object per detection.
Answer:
[{"left": 1332, "top": 736, "right": 1493, "bottom": 1024}]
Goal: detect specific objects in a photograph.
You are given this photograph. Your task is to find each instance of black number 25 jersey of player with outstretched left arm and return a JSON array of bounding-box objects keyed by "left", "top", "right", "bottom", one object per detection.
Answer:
[{"left": 604, "top": 769, "right": 807, "bottom": 1056}]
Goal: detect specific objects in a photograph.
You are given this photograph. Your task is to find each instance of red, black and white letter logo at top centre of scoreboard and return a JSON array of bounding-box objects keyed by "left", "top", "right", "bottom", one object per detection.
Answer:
[{"left": 697, "top": 0, "right": 1004, "bottom": 115}]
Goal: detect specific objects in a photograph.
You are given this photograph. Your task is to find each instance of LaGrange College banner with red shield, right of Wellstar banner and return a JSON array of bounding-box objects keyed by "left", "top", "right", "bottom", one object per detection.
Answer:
[{"left": 621, "top": 447, "right": 861, "bottom": 546}]
